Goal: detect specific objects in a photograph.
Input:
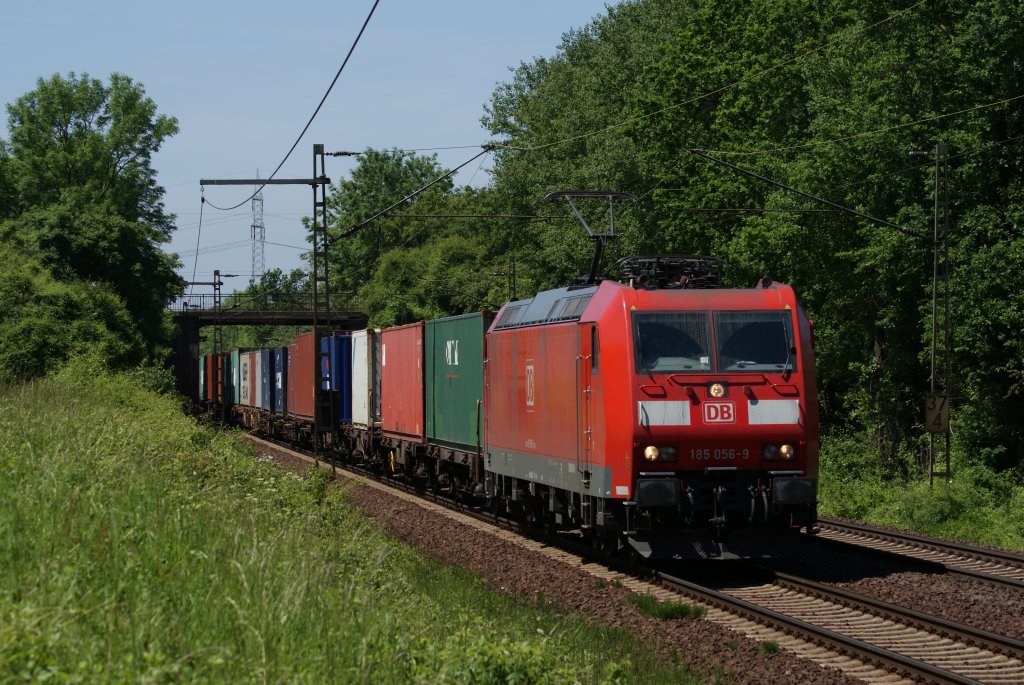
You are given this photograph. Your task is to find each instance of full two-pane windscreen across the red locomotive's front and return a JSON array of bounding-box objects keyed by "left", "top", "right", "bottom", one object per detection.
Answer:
[{"left": 633, "top": 311, "right": 796, "bottom": 374}]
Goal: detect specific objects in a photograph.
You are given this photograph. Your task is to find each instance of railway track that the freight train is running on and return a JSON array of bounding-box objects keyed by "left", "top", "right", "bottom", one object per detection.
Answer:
[{"left": 241, "top": 438, "right": 1024, "bottom": 683}]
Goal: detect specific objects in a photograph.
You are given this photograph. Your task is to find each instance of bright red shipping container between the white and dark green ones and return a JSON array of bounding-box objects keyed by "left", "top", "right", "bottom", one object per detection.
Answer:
[{"left": 381, "top": 322, "right": 425, "bottom": 442}]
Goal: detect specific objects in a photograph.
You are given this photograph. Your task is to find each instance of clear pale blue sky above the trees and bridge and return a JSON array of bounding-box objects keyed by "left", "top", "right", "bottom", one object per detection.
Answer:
[{"left": 0, "top": 0, "right": 614, "bottom": 290}]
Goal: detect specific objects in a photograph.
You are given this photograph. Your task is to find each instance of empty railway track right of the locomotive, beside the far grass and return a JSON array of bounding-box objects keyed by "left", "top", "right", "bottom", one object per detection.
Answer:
[{"left": 811, "top": 517, "right": 1024, "bottom": 590}]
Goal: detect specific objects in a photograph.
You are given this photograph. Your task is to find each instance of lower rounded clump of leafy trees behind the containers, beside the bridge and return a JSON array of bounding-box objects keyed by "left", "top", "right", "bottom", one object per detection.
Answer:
[{"left": 329, "top": 149, "right": 516, "bottom": 326}]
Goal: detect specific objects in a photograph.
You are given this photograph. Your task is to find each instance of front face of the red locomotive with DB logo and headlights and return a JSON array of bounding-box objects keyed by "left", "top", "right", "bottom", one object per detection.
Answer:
[{"left": 602, "top": 262, "right": 818, "bottom": 556}]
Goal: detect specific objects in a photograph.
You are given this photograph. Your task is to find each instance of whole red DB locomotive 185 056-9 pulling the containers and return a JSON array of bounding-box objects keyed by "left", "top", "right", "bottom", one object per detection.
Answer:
[{"left": 483, "top": 257, "right": 818, "bottom": 557}]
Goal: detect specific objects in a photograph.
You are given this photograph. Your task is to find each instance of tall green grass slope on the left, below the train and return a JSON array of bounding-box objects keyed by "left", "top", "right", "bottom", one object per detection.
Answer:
[{"left": 0, "top": 362, "right": 692, "bottom": 683}]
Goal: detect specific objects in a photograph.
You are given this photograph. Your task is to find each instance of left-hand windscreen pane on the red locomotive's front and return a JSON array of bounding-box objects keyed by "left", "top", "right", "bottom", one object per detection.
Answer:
[{"left": 633, "top": 311, "right": 711, "bottom": 373}]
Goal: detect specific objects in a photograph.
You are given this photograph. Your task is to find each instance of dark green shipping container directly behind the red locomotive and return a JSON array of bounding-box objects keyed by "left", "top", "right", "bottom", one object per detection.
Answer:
[{"left": 423, "top": 312, "right": 494, "bottom": 452}]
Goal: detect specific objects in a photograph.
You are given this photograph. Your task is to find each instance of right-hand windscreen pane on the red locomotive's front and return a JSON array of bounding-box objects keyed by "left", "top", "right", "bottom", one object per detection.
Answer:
[{"left": 715, "top": 311, "right": 797, "bottom": 372}]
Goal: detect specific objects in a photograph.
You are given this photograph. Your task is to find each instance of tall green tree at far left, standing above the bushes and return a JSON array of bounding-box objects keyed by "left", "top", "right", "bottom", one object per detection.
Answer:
[{"left": 0, "top": 73, "right": 181, "bottom": 356}]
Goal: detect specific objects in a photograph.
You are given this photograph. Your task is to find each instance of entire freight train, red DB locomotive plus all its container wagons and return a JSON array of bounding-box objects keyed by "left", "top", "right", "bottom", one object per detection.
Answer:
[{"left": 200, "top": 256, "right": 818, "bottom": 558}]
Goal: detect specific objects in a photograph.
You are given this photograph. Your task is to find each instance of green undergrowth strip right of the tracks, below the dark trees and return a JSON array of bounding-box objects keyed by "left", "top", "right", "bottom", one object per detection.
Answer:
[{"left": 819, "top": 435, "right": 1024, "bottom": 551}]
